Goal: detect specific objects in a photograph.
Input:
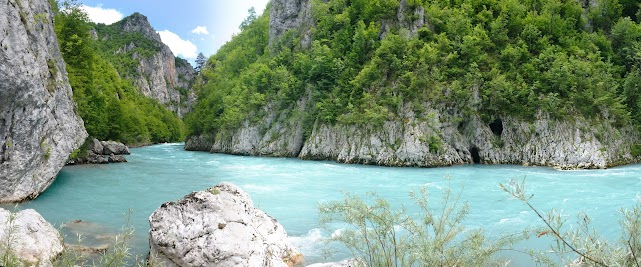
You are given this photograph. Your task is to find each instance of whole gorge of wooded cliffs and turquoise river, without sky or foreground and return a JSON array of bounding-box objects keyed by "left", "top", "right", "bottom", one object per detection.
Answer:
[{"left": 0, "top": 0, "right": 641, "bottom": 266}]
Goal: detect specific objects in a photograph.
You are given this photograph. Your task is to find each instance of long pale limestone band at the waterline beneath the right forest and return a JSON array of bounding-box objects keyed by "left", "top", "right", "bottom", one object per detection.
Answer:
[{"left": 185, "top": 103, "right": 640, "bottom": 169}]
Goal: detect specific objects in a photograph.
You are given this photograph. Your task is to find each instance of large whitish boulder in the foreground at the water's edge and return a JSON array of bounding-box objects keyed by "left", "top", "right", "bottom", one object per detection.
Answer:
[{"left": 149, "top": 183, "right": 303, "bottom": 267}]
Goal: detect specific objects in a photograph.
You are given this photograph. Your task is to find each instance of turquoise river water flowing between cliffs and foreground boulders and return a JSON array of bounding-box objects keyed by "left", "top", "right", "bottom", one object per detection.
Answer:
[{"left": 8, "top": 144, "right": 641, "bottom": 266}]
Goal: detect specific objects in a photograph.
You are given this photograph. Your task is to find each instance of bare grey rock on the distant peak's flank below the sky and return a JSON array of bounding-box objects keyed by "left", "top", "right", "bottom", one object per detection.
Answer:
[{"left": 107, "top": 13, "right": 196, "bottom": 118}]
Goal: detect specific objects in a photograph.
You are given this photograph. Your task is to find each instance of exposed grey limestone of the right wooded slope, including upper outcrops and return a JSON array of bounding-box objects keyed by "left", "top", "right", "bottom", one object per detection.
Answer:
[{"left": 185, "top": 0, "right": 641, "bottom": 169}]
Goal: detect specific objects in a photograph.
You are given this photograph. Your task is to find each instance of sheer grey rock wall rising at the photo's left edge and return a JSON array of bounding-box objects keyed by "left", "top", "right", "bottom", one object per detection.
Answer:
[{"left": 0, "top": 0, "right": 87, "bottom": 203}]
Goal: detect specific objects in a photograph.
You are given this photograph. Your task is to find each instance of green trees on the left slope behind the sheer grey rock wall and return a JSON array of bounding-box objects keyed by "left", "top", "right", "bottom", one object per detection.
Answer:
[{"left": 50, "top": 0, "right": 184, "bottom": 145}]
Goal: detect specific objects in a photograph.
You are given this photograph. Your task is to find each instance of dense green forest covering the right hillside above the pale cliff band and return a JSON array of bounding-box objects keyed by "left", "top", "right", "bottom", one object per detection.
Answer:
[{"left": 186, "top": 0, "right": 641, "bottom": 139}]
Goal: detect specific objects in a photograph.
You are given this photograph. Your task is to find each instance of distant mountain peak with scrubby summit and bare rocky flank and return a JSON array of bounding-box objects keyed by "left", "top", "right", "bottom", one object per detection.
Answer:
[{"left": 96, "top": 13, "right": 196, "bottom": 117}]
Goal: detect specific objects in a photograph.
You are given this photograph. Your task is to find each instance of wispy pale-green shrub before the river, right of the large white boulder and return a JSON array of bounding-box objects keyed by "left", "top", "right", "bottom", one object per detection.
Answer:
[{"left": 319, "top": 179, "right": 525, "bottom": 267}]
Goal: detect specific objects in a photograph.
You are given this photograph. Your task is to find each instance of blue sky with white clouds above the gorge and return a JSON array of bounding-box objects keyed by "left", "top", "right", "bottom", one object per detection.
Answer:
[{"left": 78, "top": 0, "right": 269, "bottom": 63}]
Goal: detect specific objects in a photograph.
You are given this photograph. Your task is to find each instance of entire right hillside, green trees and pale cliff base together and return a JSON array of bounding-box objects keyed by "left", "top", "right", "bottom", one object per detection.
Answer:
[{"left": 187, "top": 0, "right": 641, "bottom": 168}]
